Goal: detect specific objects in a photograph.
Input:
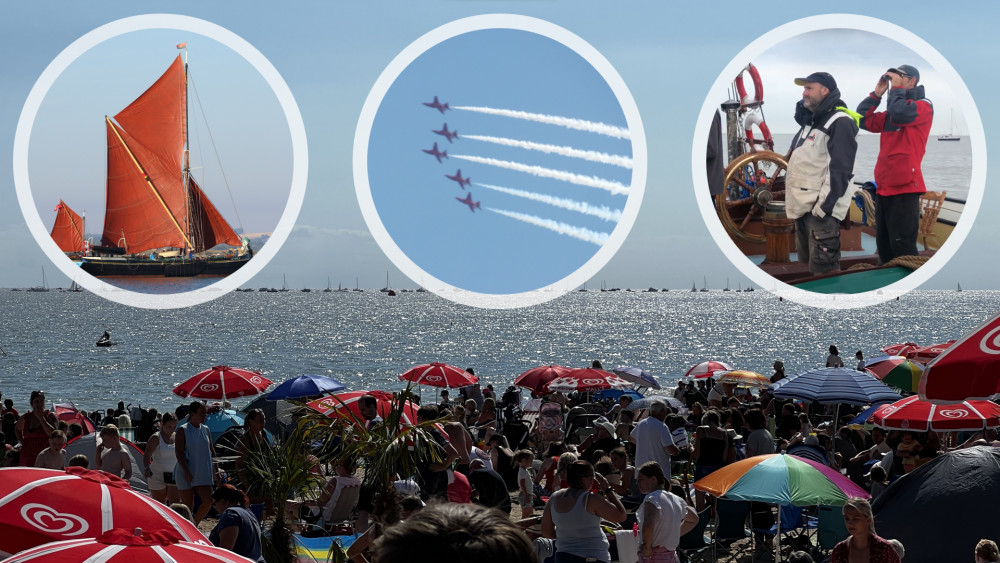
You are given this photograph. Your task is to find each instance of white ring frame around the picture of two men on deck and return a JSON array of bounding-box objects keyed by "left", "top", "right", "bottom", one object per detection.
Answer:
[{"left": 691, "top": 14, "right": 986, "bottom": 309}]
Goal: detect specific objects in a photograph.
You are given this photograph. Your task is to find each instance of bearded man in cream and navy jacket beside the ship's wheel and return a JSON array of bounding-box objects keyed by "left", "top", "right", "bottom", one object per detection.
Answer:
[{"left": 785, "top": 72, "right": 858, "bottom": 274}]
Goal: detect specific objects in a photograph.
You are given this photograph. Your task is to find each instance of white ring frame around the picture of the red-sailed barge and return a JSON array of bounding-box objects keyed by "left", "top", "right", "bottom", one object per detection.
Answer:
[{"left": 14, "top": 14, "right": 309, "bottom": 309}]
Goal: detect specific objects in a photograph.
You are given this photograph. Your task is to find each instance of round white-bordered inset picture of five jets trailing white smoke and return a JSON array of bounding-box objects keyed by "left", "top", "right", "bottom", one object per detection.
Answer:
[{"left": 355, "top": 15, "right": 645, "bottom": 308}]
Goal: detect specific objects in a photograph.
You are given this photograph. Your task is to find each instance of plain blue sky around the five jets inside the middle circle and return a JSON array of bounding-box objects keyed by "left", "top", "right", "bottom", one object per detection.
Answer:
[{"left": 368, "top": 29, "right": 632, "bottom": 294}]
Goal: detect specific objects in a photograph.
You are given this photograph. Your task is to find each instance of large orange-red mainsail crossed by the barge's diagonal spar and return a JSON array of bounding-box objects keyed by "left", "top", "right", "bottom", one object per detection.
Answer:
[{"left": 101, "top": 122, "right": 187, "bottom": 253}]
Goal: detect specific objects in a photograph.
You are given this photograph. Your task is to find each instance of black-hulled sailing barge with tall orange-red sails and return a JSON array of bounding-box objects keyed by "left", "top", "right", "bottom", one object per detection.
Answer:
[{"left": 81, "top": 48, "right": 253, "bottom": 276}]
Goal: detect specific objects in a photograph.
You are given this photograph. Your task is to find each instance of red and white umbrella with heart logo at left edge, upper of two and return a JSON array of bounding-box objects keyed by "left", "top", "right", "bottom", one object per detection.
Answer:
[{"left": 0, "top": 467, "right": 209, "bottom": 553}]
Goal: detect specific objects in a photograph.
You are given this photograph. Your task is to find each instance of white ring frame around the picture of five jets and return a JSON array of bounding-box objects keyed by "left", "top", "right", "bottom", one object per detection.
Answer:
[{"left": 354, "top": 14, "right": 647, "bottom": 309}]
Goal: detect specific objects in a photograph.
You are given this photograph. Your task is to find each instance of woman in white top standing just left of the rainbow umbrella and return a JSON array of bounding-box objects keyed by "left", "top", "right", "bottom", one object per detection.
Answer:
[{"left": 635, "top": 461, "right": 698, "bottom": 563}]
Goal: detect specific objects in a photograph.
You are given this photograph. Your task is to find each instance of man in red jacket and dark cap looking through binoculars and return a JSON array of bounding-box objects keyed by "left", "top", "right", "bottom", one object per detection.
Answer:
[{"left": 858, "top": 65, "right": 934, "bottom": 264}]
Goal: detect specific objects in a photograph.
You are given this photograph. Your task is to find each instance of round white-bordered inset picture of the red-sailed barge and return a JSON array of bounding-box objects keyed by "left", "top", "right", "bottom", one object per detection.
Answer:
[{"left": 15, "top": 15, "right": 305, "bottom": 308}]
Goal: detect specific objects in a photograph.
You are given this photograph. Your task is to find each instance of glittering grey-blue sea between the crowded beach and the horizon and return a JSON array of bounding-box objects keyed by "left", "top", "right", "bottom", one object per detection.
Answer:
[{"left": 0, "top": 290, "right": 1000, "bottom": 409}]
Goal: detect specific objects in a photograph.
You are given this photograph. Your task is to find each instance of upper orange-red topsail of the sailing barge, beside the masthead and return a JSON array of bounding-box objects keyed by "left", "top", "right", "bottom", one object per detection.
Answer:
[{"left": 115, "top": 55, "right": 187, "bottom": 178}]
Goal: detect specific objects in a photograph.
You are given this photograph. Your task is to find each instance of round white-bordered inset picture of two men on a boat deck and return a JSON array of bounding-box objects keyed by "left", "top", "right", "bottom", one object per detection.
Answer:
[{"left": 692, "top": 16, "right": 986, "bottom": 308}]
